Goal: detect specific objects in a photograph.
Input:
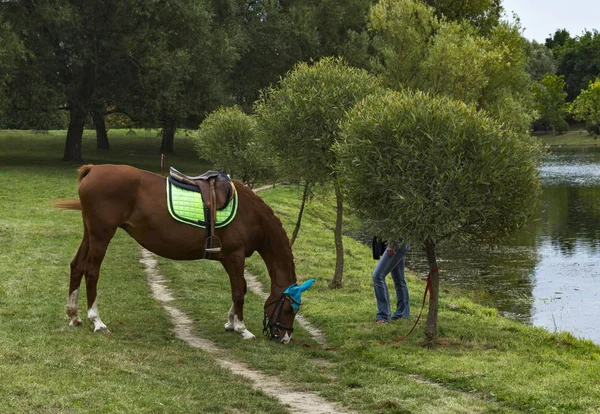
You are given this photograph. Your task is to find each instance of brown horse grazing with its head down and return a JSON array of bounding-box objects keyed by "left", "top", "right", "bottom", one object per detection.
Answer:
[{"left": 55, "top": 165, "right": 310, "bottom": 343}]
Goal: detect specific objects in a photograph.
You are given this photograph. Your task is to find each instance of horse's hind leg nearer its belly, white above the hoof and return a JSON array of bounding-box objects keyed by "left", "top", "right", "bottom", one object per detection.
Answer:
[{"left": 85, "top": 228, "right": 116, "bottom": 332}]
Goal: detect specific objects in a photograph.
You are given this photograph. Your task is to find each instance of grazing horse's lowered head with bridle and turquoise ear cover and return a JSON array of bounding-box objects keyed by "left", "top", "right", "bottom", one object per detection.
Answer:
[{"left": 263, "top": 279, "right": 315, "bottom": 344}]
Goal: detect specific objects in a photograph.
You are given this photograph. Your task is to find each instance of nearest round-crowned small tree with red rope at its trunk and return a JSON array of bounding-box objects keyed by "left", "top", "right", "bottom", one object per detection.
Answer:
[{"left": 335, "top": 92, "right": 540, "bottom": 341}]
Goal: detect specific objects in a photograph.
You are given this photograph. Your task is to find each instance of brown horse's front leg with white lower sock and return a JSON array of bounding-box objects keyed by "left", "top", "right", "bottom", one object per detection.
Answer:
[{"left": 221, "top": 254, "right": 256, "bottom": 339}]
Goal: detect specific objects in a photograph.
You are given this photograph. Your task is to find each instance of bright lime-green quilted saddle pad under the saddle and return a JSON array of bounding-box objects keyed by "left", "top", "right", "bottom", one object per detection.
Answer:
[{"left": 167, "top": 178, "right": 238, "bottom": 228}]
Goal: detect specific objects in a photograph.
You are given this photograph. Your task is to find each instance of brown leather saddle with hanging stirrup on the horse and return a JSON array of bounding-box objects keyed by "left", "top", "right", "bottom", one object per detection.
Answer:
[{"left": 169, "top": 167, "right": 235, "bottom": 258}]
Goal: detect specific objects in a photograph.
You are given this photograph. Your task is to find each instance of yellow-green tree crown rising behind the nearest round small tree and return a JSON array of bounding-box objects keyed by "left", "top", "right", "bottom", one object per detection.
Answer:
[{"left": 369, "top": 0, "right": 533, "bottom": 132}]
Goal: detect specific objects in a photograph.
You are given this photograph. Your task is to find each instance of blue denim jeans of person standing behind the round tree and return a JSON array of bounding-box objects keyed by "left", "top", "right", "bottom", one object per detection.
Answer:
[{"left": 373, "top": 244, "right": 410, "bottom": 322}]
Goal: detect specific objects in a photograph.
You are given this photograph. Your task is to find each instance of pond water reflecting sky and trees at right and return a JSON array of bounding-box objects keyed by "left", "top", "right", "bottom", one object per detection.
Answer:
[{"left": 407, "top": 148, "right": 600, "bottom": 344}]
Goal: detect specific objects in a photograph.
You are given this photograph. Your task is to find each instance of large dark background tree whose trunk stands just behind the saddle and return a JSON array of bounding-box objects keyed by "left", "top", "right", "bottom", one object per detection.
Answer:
[{"left": 150, "top": 1, "right": 244, "bottom": 153}]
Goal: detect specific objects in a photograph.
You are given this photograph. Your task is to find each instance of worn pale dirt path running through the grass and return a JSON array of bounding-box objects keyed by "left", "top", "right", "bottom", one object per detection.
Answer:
[{"left": 140, "top": 248, "right": 349, "bottom": 414}]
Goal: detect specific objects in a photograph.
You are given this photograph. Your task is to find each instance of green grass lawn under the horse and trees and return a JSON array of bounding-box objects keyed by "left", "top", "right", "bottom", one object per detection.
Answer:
[{"left": 0, "top": 131, "right": 600, "bottom": 413}]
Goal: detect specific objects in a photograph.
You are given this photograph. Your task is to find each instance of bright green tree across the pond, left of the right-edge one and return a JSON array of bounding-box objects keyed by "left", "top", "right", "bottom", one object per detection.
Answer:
[{"left": 531, "top": 74, "right": 568, "bottom": 133}]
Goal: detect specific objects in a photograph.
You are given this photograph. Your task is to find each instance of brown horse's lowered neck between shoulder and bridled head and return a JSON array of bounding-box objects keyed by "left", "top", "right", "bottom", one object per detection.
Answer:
[{"left": 258, "top": 204, "right": 296, "bottom": 294}]
